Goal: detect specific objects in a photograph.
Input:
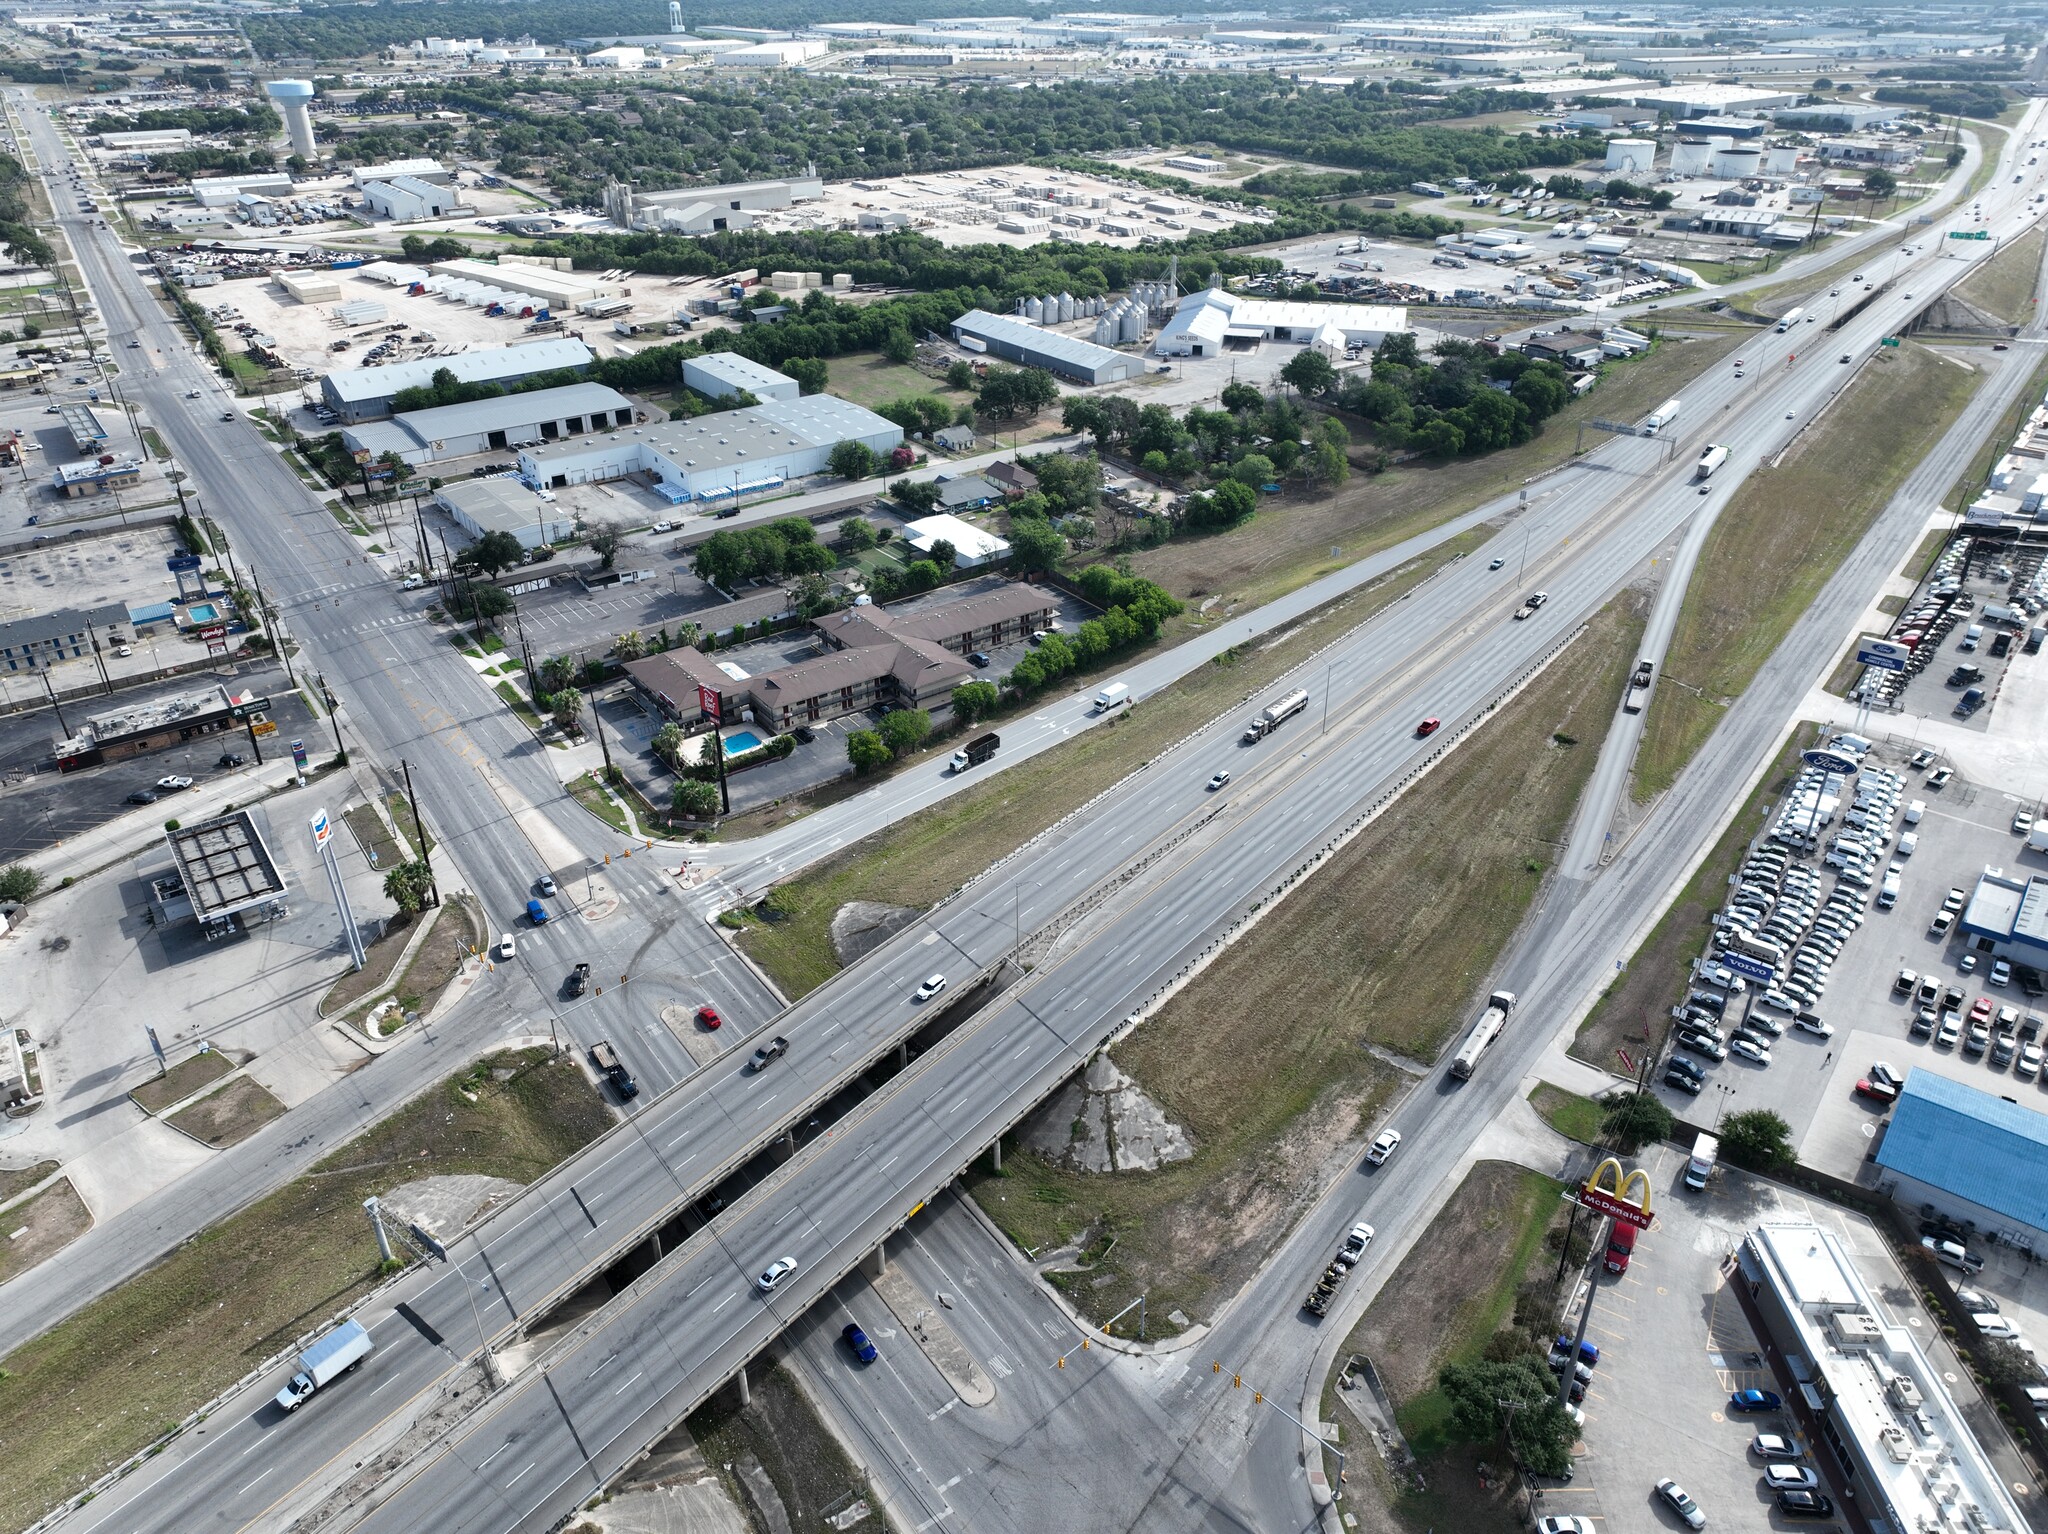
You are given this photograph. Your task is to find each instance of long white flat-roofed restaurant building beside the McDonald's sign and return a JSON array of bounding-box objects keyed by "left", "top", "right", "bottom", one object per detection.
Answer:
[{"left": 1737, "top": 1220, "right": 2038, "bottom": 1532}]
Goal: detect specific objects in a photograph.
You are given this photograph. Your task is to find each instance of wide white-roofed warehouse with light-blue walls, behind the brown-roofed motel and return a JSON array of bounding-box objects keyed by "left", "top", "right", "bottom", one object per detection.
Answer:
[{"left": 518, "top": 393, "right": 903, "bottom": 504}]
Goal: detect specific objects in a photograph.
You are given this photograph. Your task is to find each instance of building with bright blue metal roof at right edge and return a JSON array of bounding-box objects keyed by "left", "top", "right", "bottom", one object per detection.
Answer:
[{"left": 1876, "top": 1071, "right": 2048, "bottom": 1243}]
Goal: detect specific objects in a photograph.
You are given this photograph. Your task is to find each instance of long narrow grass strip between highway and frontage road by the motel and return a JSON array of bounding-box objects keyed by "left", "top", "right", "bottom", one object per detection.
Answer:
[{"left": 739, "top": 532, "right": 1483, "bottom": 997}]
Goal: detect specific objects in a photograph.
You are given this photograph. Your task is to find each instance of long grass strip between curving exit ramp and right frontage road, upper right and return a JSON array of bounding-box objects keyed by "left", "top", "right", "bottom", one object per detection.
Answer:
[{"left": 1632, "top": 346, "right": 1982, "bottom": 803}]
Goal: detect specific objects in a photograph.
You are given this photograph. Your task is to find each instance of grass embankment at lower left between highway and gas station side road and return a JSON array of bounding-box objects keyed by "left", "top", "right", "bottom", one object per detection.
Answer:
[{"left": 0, "top": 1049, "right": 612, "bottom": 1528}]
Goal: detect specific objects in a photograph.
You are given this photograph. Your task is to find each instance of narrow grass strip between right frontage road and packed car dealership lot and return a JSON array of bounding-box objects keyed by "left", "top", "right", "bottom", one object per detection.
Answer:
[{"left": 1571, "top": 733, "right": 1812, "bottom": 1073}]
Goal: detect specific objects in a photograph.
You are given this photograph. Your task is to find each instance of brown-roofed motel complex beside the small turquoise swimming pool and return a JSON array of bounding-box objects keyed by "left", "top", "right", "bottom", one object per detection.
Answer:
[{"left": 627, "top": 584, "right": 1059, "bottom": 731}]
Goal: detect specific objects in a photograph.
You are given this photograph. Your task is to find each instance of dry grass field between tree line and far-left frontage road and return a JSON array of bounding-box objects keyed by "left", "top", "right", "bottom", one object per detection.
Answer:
[{"left": 1133, "top": 332, "right": 1747, "bottom": 604}]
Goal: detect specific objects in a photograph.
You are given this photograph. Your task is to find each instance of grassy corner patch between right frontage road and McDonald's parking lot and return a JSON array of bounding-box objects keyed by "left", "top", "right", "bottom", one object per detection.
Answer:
[{"left": 1337, "top": 1161, "right": 1565, "bottom": 1534}]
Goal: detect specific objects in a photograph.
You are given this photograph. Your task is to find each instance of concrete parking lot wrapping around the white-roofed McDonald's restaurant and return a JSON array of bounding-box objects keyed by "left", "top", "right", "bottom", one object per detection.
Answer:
[{"left": 1536, "top": 1147, "right": 1998, "bottom": 1530}]
